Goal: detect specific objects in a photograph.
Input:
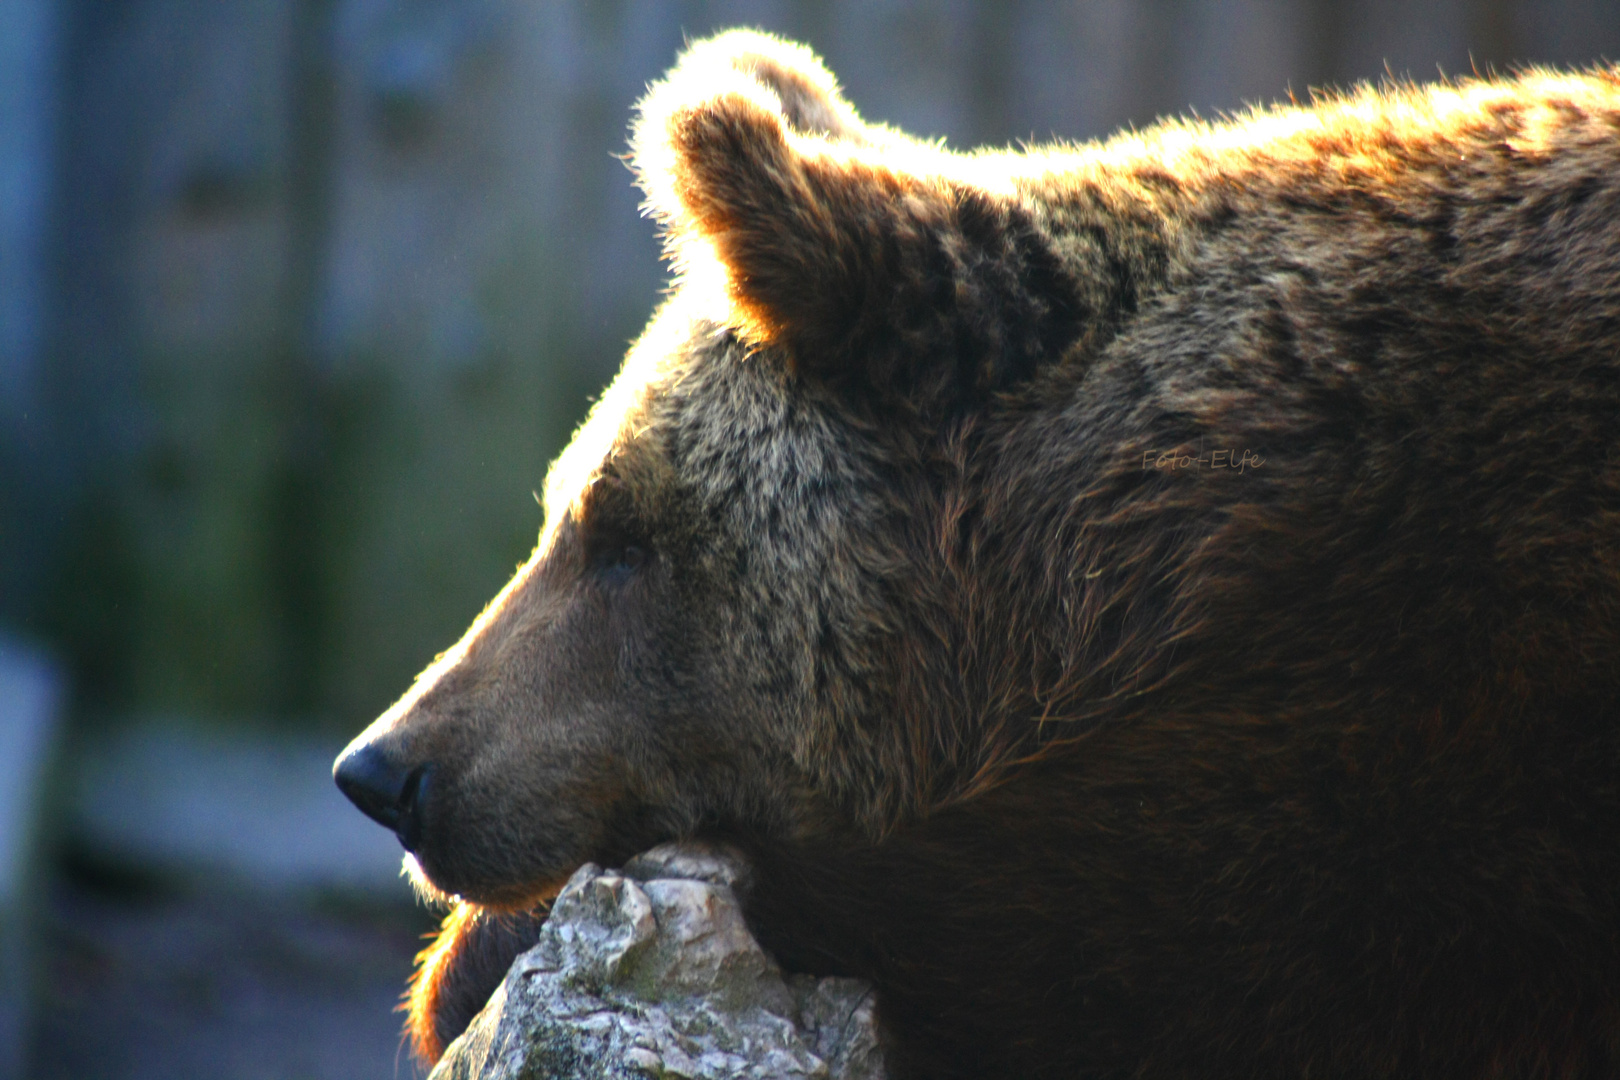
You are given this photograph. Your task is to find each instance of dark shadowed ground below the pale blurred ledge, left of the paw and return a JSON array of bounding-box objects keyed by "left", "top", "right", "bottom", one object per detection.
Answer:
[{"left": 29, "top": 860, "right": 429, "bottom": 1080}]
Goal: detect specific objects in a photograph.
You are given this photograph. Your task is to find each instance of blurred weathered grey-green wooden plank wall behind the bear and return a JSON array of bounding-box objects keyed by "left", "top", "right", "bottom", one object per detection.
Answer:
[{"left": 9, "top": 0, "right": 1620, "bottom": 727}]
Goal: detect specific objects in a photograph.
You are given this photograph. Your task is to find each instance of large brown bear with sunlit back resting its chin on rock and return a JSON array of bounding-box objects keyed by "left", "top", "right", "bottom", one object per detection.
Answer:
[{"left": 337, "top": 32, "right": 1620, "bottom": 1078}]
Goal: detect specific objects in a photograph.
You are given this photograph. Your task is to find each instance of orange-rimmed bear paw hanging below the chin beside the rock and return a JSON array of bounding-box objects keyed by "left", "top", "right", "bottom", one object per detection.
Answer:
[{"left": 402, "top": 904, "right": 546, "bottom": 1065}]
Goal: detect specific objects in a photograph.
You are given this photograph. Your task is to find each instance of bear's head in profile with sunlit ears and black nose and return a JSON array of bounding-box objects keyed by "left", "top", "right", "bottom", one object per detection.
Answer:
[{"left": 337, "top": 32, "right": 1119, "bottom": 907}]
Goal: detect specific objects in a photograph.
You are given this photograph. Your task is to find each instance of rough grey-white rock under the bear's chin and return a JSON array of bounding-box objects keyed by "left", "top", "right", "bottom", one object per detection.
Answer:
[{"left": 429, "top": 844, "right": 883, "bottom": 1080}]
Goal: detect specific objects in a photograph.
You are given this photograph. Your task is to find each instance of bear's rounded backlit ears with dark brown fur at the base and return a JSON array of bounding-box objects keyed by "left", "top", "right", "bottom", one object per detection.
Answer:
[{"left": 632, "top": 32, "right": 1064, "bottom": 397}]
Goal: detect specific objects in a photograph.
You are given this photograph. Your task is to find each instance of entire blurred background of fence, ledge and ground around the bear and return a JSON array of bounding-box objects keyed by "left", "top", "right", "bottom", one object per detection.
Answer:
[{"left": 0, "top": 0, "right": 1620, "bottom": 1080}]
